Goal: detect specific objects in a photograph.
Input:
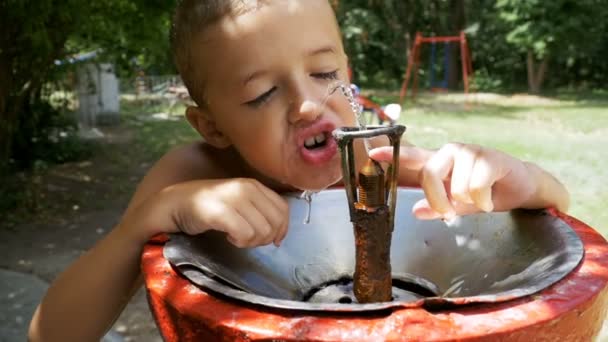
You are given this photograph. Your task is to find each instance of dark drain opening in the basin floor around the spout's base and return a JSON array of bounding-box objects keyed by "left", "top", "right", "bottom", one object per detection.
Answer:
[{"left": 302, "top": 277, "right": 436, "bottom": 304}]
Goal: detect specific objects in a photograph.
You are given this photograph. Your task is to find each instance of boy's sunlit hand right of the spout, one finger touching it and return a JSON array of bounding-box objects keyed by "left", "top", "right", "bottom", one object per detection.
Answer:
[{"left": 370, "top": 143, "right": 538, "bottom": 219}]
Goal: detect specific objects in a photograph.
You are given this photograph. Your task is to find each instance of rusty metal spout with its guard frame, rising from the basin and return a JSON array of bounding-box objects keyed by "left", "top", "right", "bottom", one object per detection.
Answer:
[{"left": 333, "top": 125, "right": 405, "bottom": 303}]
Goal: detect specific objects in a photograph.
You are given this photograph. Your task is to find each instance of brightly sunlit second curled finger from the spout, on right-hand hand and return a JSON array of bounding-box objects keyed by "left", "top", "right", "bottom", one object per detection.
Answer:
[{"left": 450, "top": 145, "right": 479, "bottom": 204}]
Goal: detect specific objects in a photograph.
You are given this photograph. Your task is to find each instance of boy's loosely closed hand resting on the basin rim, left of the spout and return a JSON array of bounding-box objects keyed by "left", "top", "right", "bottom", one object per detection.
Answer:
[{"left": 126, "top": 178, "right": 289, "bottom": 248}]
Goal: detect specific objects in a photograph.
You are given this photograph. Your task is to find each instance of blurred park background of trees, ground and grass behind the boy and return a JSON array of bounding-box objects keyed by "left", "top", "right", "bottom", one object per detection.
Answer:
[{"left": 0, "top": 0, "right": 608, "bottom": 341}]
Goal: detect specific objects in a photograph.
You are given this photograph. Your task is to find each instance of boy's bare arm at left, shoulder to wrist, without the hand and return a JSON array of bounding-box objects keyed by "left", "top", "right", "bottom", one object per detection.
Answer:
[{"left": 29, "top": 144, "right": 217, "bottom": 341}]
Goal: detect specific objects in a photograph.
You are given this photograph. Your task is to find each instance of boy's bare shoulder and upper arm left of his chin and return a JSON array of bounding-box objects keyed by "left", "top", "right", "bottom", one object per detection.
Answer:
[{"left": 124, "top": 142, "right": 241, "bottom": 211}]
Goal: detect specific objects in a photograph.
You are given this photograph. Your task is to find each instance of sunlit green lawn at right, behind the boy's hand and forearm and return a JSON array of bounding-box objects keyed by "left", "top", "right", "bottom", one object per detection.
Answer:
[{"left": 384, "top": 96, "right": 608, "bottom": 236}]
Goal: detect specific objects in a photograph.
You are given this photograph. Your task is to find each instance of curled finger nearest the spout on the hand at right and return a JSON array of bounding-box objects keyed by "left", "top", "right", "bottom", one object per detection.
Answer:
[{"left": 420, "top": 144, "right": 459, "bottom": 218}]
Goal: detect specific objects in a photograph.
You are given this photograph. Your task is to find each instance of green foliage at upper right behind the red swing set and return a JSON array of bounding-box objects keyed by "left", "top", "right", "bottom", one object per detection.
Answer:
[{"left": 338, "top": 0, "right": 608, "bottom": 90}]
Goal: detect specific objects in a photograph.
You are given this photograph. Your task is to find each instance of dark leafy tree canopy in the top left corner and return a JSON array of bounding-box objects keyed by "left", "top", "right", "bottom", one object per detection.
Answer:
[{"left": 0, "top": 0, "right": 174, "bottom": 175}]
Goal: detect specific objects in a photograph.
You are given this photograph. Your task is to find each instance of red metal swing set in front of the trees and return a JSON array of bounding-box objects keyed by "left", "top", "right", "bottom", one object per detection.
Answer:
[{"left": 399, "top": 31, "right": 473, "bottom": 103}]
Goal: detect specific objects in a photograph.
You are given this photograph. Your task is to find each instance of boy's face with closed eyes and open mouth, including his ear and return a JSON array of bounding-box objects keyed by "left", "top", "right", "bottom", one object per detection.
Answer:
[{"left": 189, "top": 0, "right": 355, "bottom": 190}]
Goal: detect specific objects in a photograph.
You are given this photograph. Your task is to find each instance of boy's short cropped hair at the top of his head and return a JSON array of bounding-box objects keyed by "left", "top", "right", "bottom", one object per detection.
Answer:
[{"left": 170, "top": 0, "right": 267, "bottom": 106}]
